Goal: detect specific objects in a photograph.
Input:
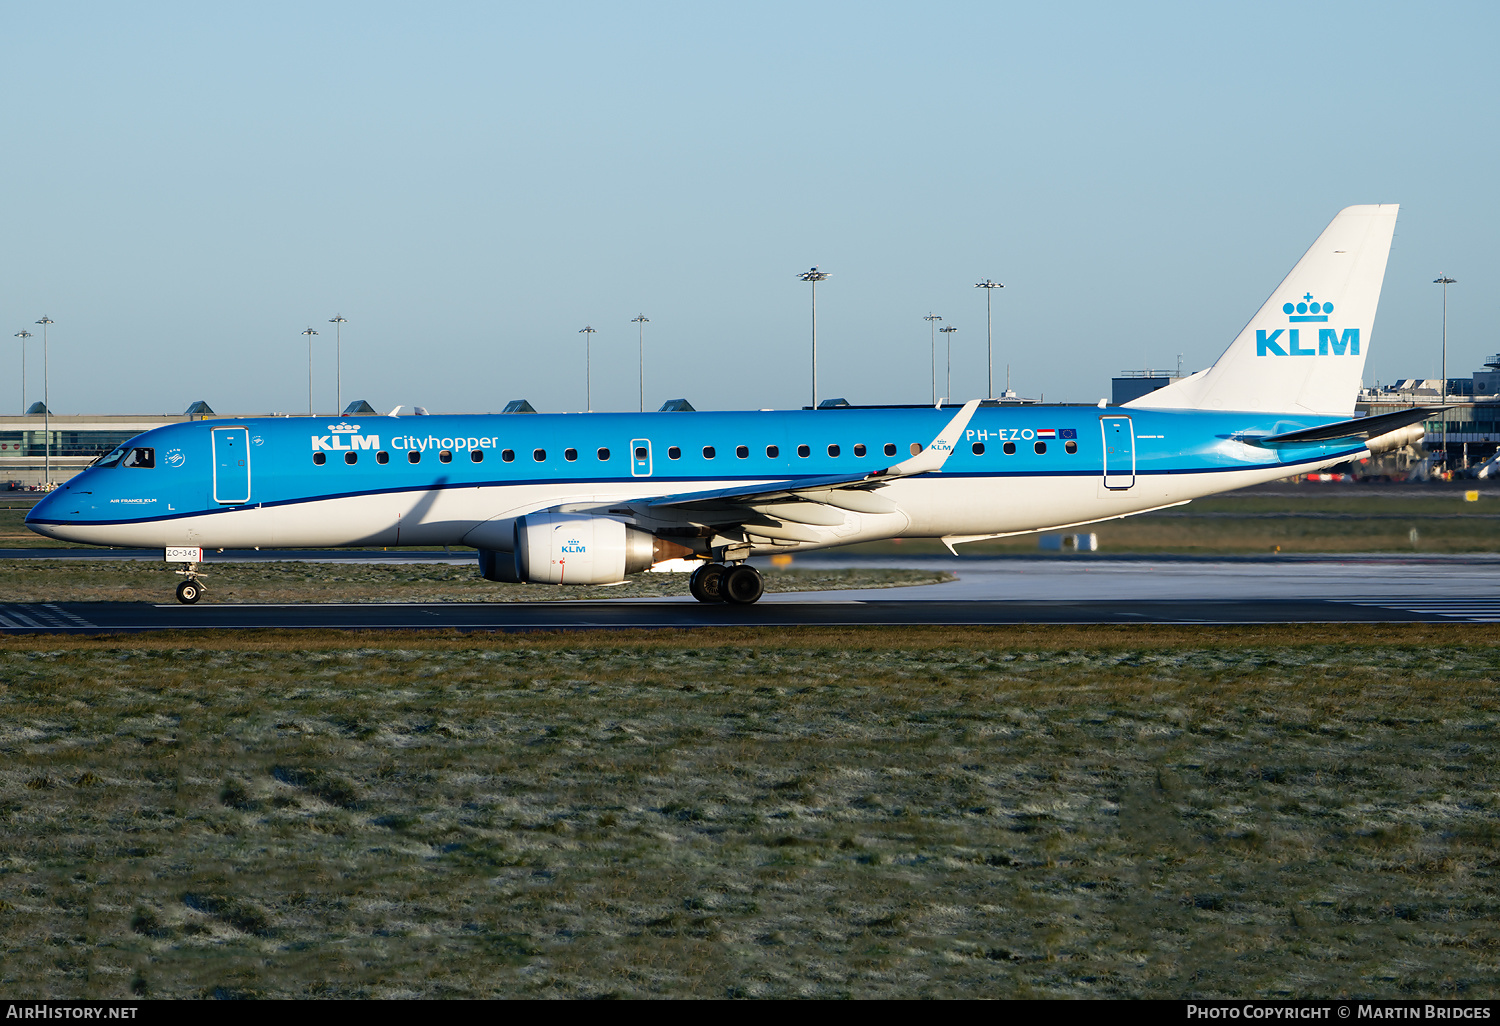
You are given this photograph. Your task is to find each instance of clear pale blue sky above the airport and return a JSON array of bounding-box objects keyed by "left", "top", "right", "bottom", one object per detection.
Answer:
[{"left": 0, "top": 3, "right": 1500, "bottom": 413}]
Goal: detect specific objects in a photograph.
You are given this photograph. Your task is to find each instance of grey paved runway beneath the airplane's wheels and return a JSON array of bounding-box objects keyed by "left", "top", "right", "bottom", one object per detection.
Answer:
[{"left": 0, "top": 551, "right": 1500, "bottom": 633}]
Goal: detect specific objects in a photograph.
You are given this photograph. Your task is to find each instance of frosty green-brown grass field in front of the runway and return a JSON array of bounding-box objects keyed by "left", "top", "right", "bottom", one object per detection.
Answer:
[{"left": 0, "top": 626, "right": 1500, "bottom": 998}]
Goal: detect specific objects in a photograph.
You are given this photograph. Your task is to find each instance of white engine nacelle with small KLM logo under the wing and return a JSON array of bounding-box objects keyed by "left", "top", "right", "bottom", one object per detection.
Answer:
[{"left": 507, "top": 510, "right": 692, "bottom": 585}]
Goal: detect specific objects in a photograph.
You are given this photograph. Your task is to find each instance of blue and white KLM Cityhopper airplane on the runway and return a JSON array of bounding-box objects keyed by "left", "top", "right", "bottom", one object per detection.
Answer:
[{"left": 26, "top": 204, "right": 1440, "bottom": 606}]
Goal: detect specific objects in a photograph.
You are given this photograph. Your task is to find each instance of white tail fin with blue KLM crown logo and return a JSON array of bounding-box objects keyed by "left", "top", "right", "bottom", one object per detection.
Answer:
[{"left": 1125, "top": 204, "right": 1398, "bottom": 417}]
